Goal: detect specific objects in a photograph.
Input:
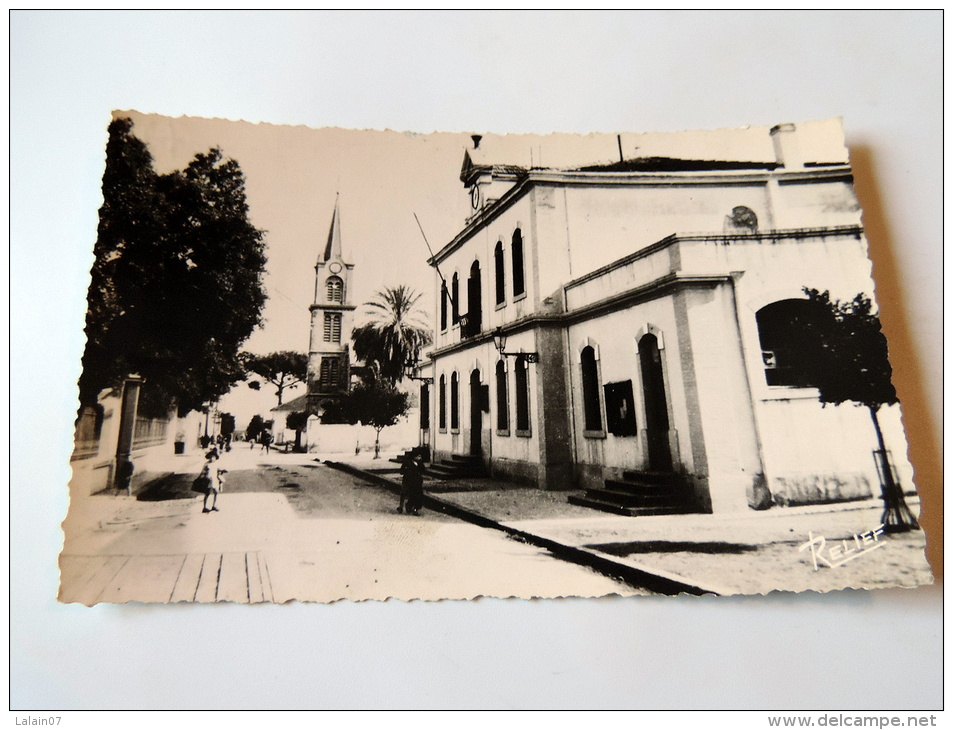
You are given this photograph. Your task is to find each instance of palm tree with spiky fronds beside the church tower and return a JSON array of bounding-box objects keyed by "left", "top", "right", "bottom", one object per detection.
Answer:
[{"left": 351, "top": 284, "right": 432, "bottom": 383}]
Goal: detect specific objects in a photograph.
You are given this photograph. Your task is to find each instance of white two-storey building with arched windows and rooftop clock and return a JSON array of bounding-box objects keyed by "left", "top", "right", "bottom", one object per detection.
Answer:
[{"left": 429, "top": 125, "right": 912, "bottom": 512}]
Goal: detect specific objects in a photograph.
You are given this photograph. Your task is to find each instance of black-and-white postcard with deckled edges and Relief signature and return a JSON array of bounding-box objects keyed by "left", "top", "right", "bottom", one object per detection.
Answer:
[{"left": 59, "top": 112, "right": 933, "bottom": 605}]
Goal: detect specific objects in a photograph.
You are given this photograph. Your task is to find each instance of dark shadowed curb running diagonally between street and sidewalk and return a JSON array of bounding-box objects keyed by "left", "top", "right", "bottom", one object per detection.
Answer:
[{"left": 322, "top": 461, "right": 724, "bottom": 596}]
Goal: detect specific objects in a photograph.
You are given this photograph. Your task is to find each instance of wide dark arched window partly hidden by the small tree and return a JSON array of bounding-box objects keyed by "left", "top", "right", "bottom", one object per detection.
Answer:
[{"left": 755, "top": 299, "right": 829, "bottom": 388}]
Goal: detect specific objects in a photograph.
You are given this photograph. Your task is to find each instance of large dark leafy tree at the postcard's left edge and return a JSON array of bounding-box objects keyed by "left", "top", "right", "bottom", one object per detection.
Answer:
[{"left": 80, "top": 119, "right": 266, "bottom": 415}]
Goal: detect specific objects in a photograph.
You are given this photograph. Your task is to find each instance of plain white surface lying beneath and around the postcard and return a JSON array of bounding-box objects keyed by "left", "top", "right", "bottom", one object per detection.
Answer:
[{"left": 10, "top": 11, "right": 942, "bottom": 711}]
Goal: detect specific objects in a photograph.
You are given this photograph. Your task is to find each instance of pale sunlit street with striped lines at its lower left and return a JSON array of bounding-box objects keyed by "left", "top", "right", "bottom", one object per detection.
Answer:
[{"left": 60, "top": 444, "right": 648, "bottom": 605}]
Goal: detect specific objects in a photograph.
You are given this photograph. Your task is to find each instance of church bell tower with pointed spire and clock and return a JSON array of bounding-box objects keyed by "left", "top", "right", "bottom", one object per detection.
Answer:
[{"left": 308, "top": 200, "right": 356, "bottom": 413}]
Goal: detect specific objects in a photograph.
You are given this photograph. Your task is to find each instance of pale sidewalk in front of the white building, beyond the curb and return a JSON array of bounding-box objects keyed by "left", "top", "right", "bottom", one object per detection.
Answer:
[{"left": 330, "top": 461, "right": 933, "bottom": 595}]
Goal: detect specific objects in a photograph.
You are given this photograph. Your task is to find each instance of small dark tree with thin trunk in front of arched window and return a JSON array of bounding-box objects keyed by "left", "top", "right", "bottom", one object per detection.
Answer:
[{"left": 801, "top": 289, "right": 919, "bottom": 532}]
